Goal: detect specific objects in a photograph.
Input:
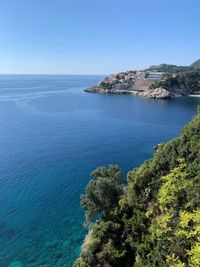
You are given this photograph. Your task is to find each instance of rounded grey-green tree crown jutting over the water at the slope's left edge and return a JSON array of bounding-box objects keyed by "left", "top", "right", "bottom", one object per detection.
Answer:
[{"left": 81, "top": 165, "right": 123, "bottom": 225}]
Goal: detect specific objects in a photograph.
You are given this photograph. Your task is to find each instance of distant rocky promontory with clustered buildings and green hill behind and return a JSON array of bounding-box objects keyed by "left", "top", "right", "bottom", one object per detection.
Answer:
[{"left": 85, "top": 60, "right": 200, "bottom": 99}]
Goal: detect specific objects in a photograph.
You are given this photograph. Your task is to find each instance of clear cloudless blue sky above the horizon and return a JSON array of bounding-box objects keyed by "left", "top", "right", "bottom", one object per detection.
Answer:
[{"left": 0, "top": 0, "right": 200, "bottom": 74}]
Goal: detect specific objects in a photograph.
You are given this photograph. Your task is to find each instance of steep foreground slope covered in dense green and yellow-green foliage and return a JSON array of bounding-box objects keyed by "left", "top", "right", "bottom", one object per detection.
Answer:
[{"left": 75, "top": 107, "right": 200, "bottom": 267}]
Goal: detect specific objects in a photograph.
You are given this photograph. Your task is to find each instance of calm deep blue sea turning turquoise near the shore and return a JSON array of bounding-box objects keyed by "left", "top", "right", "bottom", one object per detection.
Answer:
[{"left": 0, "top": 75, "right": 200, "bottom": 267}]
